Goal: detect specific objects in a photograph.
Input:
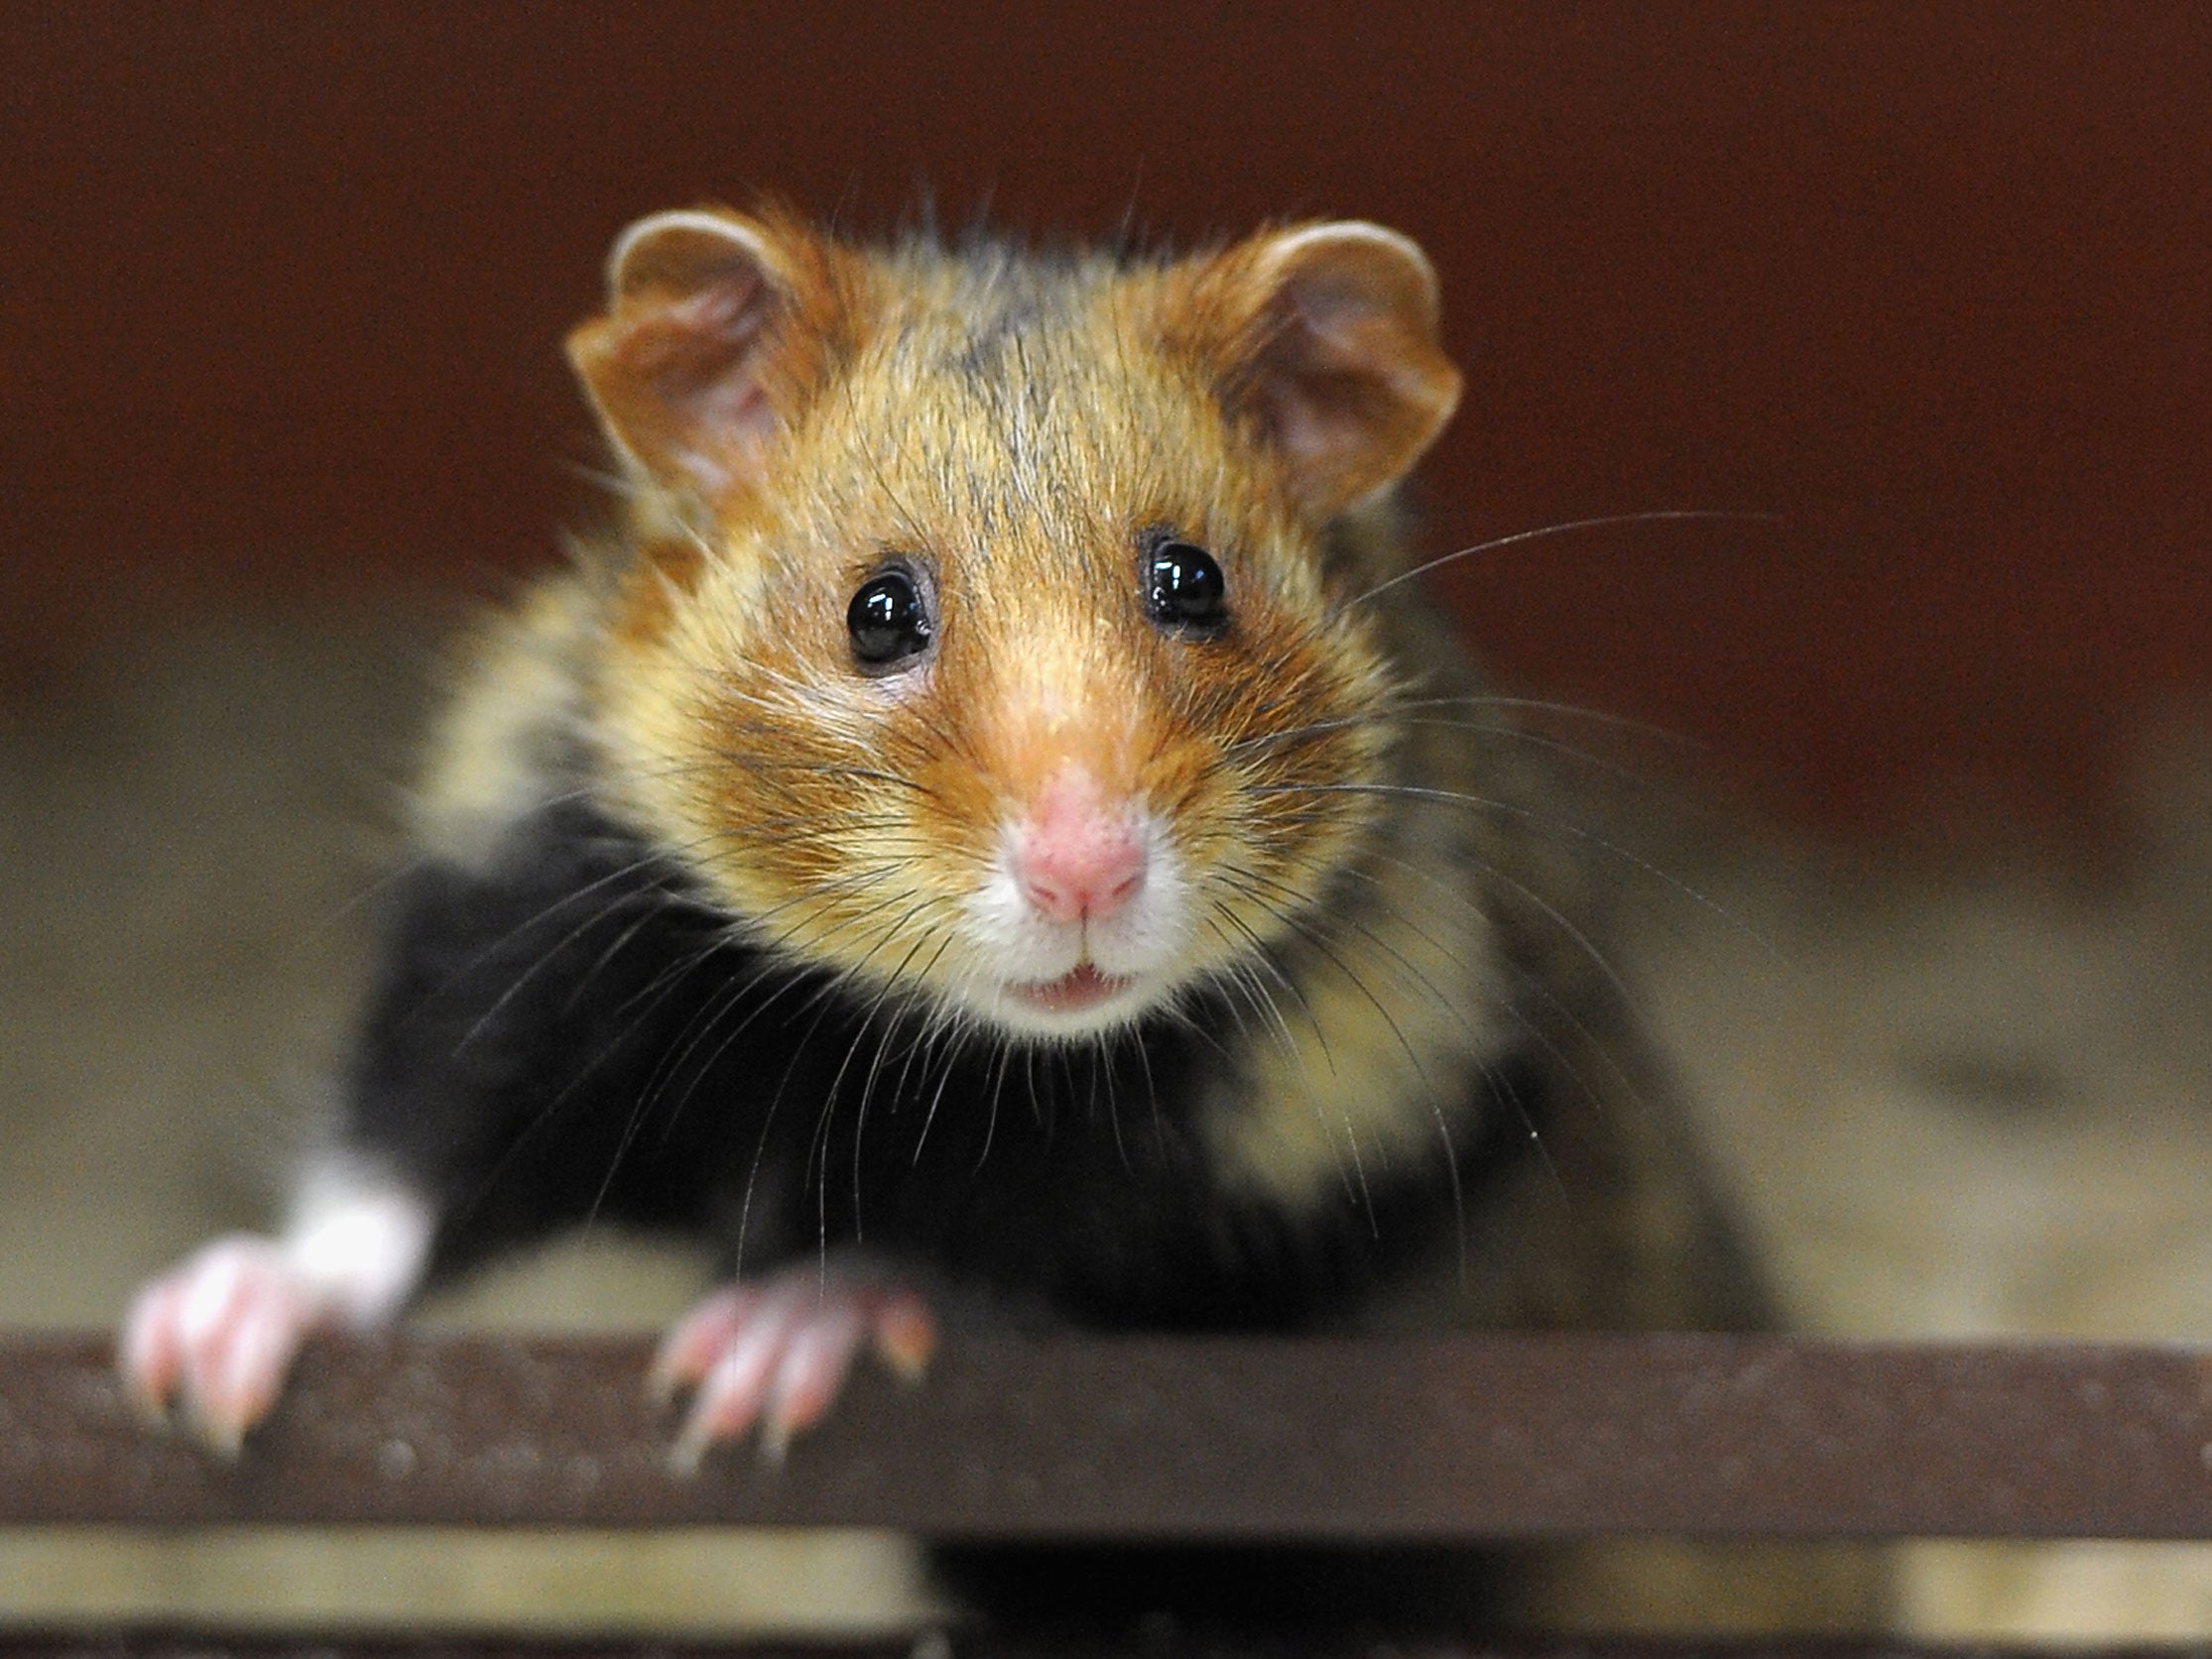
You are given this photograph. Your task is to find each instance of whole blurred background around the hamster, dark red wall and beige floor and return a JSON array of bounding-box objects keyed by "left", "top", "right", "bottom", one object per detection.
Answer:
[{"left": 0, "top": 2, "right": 2212, "bottom": 1634}]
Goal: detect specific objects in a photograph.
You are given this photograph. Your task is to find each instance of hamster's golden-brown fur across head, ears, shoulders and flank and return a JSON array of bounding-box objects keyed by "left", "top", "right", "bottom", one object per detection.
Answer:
[{"left": 433, "top": 214, "right": 1757, "bottom": 1323}]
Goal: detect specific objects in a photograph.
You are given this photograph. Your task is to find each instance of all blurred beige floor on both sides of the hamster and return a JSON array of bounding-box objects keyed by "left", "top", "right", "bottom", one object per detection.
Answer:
[{"left": 0, "top": 611, "right": 2212, "bottom": 1637}]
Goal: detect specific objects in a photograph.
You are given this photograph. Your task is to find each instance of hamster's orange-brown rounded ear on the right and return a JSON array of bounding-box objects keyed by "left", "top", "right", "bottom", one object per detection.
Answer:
[{"left": 1170, "top": 221, "right": 1460, "bottom": 518}]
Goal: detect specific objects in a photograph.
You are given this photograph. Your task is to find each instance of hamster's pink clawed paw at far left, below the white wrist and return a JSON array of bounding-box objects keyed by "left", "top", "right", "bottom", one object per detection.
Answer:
[{"left": 117, "top": 1235, "right": 332, "bottom": 1458}]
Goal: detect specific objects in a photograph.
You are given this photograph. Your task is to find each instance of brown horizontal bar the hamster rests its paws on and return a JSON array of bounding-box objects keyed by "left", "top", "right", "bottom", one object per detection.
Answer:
[{"left": 0, "top": 1336, "right": 2212, "bottom": 1542}]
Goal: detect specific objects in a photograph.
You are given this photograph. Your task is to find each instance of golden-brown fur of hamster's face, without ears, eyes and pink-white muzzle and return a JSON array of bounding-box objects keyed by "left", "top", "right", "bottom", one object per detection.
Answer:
[{"left": 577, "top": 217, "right": 1389, "bottom": 1012}]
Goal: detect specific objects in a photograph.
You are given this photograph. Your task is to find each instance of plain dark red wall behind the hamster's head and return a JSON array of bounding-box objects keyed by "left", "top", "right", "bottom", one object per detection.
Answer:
[{"left": 0, "top": 2, "right": 2212, "bottom": 832}]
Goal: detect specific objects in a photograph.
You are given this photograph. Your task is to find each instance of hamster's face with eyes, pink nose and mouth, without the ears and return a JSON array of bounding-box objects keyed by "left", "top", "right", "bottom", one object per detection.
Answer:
[{"left": 579, "top": 211, "right": 1459, "bottom": 1039}]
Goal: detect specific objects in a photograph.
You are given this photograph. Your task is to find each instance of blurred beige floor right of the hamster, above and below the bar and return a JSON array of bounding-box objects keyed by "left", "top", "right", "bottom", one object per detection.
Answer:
[{"left": 1631, "top": 717, "right": 2212, "bottom": 1639}]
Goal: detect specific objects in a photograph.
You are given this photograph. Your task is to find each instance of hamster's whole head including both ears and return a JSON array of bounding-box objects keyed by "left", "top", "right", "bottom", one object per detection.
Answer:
[{"left": 570, "top": 212, "right": 1460, "bottom": 1042}]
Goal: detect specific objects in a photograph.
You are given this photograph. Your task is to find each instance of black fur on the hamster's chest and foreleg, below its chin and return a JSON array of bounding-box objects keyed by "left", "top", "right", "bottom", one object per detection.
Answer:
[{"left": 347, "top": 805, "right": 1536, "bottom": 1330}]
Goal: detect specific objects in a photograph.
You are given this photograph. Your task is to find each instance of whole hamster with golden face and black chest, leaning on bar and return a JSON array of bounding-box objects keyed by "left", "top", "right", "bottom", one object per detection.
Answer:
[{"left": 119, "top": 210, "right": 1763, "bottom": 1467}]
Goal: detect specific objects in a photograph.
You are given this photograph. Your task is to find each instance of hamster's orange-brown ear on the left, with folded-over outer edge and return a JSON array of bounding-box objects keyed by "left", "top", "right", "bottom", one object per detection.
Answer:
[{"left": 568, "top": 210, "right": 840, "bottom": 505}]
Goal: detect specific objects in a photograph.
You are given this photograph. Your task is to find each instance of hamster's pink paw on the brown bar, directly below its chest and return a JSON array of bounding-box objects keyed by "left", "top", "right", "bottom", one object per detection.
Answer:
[{"left": 651, "top": 1265, "right": 938, "bottom": 1476}]
